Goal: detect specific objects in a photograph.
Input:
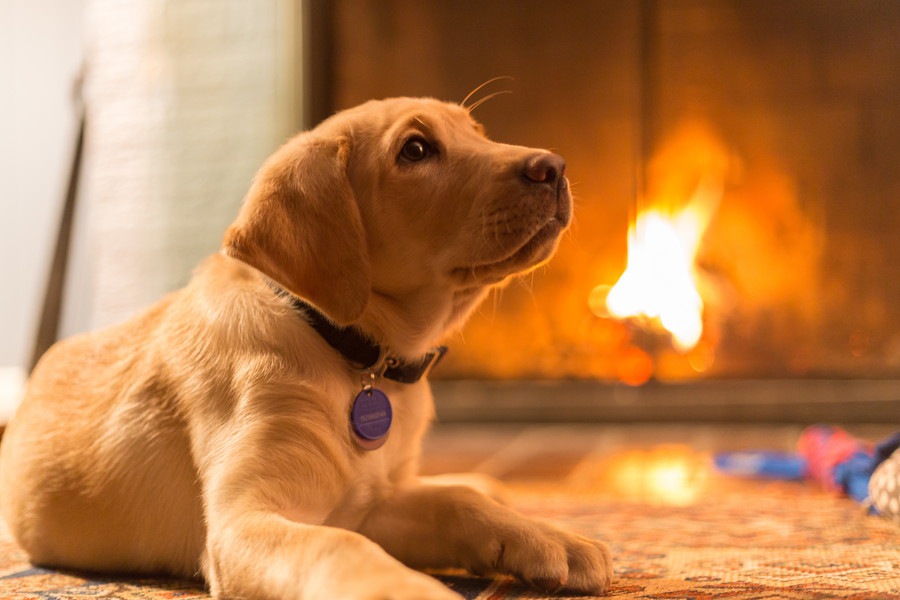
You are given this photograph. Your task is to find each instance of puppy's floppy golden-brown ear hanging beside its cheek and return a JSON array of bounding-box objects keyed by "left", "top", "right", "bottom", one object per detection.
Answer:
[{"left": 223, "top": 133, "right": 371, "bottom": 325}]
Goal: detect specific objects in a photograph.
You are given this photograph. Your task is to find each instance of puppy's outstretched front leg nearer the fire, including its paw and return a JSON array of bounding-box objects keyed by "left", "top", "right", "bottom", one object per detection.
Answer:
[{"left": 360, "top": 485, "right": 612, "bottom": 594}]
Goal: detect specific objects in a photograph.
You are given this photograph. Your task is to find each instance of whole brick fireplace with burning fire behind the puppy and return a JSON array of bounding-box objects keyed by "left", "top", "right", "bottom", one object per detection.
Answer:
[{"left": 307, "top": 0, "right": 900, "bottom": 421}]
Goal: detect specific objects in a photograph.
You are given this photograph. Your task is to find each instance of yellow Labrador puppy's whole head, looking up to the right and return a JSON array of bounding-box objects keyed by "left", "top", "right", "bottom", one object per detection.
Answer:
[{"left": 224, "top": 98, "right": 571, "bottom": 332}]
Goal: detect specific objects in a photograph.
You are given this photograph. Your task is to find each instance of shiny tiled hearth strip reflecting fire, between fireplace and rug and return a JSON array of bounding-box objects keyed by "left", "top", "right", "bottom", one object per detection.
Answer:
[{"left": 422, "top": 425, "right": 891, "bottom": 506}]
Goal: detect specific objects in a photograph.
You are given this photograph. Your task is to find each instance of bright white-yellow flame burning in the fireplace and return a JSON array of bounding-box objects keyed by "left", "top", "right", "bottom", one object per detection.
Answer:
[{"left": 606, "top": 179, "right": 722, "bottom": 352}]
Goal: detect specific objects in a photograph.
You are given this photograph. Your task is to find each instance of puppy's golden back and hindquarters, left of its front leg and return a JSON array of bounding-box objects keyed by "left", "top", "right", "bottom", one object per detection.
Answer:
[{"left": 0, "top": 293, "right": 203, "bottom": 575}]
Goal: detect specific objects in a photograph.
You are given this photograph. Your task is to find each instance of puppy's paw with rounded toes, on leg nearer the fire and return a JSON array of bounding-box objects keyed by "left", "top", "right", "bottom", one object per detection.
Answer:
[{"left": 486, "top": 521, "right": 612, "bottom": 595}]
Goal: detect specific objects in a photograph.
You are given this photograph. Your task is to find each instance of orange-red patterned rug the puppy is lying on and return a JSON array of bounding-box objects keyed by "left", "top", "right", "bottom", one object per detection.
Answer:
[{"left": 0, "top": 482, "right": 900, "bottom": 600}]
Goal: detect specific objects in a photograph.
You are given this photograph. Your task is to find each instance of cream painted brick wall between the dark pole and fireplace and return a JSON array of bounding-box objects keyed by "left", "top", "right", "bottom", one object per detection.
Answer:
[{"left": 80, "top": 0, "right": 299, "bottom": 329}]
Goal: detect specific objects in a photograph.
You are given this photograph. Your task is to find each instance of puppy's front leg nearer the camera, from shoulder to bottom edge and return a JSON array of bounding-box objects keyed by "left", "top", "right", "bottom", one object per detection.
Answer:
[{"left": 196, "top": 391, "right": 460, "bottom": 600}]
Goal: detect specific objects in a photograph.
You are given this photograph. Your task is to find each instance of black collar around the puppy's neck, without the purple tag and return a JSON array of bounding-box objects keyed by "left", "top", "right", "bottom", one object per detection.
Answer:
[{"left": 269, "top": 282, "right": 447, "bottom": 383}]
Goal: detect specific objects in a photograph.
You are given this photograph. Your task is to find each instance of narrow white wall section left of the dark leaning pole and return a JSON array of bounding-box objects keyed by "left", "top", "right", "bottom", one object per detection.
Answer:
[{"left": 0, "top": 0, "right": 86, "bottom": 420}]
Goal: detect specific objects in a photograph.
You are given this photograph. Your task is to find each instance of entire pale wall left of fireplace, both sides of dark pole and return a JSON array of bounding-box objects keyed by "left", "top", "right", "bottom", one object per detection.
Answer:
[{"left": 0, "top": 0, "right": 302, "bottom": 423}]
